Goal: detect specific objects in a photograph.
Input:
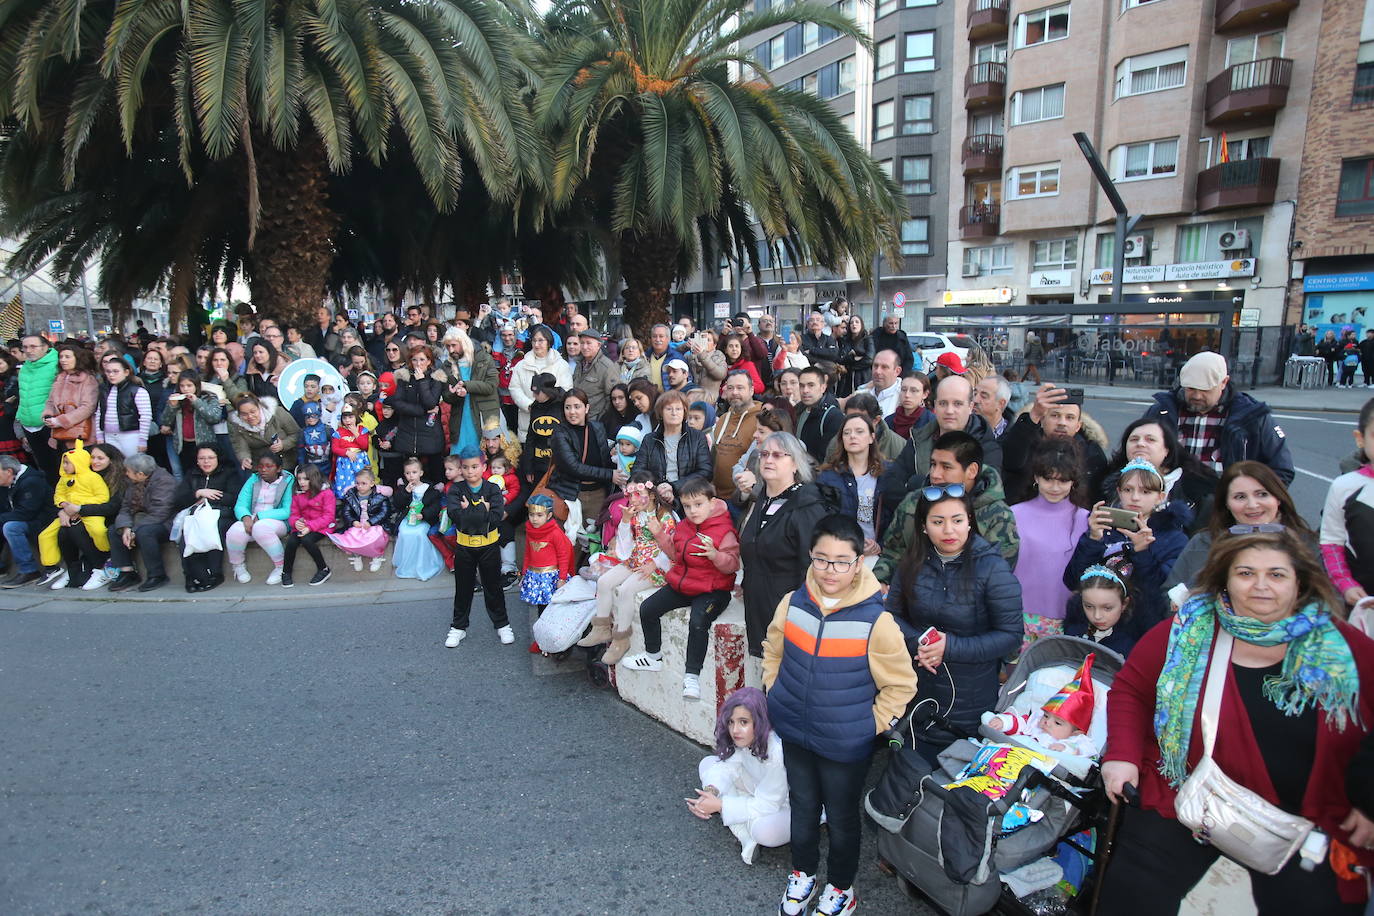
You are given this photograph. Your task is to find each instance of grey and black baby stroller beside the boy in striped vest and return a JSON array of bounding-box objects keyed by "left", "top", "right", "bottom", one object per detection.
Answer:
[{"left": 864, "top": 636, "right": 1124, "bottom": 916}]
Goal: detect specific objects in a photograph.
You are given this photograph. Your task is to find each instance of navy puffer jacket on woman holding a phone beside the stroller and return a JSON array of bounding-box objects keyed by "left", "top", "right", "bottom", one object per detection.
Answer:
[{"left": 886, "top": 534, "right": 1025, "bottom": 740}]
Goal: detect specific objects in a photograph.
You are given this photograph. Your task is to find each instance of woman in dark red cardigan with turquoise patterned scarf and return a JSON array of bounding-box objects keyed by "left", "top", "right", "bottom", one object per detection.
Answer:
[{"left": 1098, "top": 530, "right": 1374, "bottom": 916}]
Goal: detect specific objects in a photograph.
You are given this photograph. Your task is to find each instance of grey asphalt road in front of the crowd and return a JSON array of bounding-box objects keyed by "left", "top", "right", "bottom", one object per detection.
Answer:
[{"left": 0, "top": 598, "right": 929, "bottom": 916}]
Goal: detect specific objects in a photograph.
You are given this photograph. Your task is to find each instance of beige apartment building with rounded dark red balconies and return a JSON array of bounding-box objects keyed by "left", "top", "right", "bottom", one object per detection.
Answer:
[{"left": 925, "top": 0, "right": 1313, "bottom": 383}]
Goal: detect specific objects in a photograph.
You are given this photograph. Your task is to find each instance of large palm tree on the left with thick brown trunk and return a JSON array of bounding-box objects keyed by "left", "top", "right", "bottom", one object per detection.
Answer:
[{"left": 0, "top": 0, "right": 543, "bottom": 324}]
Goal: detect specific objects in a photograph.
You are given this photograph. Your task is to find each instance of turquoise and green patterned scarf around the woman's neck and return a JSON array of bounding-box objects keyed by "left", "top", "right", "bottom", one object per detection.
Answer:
[{"left": 1154, "top": 593, "right": 1360, "bottom": 788}]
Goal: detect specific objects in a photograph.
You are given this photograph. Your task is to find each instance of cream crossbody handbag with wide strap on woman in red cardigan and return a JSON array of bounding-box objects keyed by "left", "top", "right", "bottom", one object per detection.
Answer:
[{"left": 1173, "top": 628, "right": 1316, "bottom": 875}]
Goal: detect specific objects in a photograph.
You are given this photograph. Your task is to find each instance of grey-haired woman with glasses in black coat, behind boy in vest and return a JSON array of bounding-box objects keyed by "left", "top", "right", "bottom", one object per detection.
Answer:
[{"left": 736, "top": 433, "right": 830, "bottom": 658}]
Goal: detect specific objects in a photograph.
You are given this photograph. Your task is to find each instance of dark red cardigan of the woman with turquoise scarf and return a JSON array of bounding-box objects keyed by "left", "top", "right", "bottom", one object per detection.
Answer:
[{"left": 1102, "top": 621, "right": 1374, "bottom": 889}]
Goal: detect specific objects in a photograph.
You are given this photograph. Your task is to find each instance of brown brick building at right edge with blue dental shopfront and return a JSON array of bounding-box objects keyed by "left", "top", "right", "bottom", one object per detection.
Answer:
[{"left": 1287, "top": 0, "right": 1374, "bottom": 339}]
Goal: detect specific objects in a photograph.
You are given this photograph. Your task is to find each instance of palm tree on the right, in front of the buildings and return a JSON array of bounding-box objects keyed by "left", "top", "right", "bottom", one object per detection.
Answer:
[{"left": 536, "top": 0, "right": 904, "bottom": 339}]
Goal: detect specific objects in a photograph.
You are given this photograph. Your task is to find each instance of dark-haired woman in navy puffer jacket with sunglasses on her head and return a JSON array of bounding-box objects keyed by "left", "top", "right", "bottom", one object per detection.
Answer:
[{"left": 886, "top": 493, "right": 1025, "bottom": 766}]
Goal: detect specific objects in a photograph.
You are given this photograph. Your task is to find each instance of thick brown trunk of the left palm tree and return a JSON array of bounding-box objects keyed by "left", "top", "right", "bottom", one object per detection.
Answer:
[{"left": 249, "top": 132, "right": 338, "bottom": 325}]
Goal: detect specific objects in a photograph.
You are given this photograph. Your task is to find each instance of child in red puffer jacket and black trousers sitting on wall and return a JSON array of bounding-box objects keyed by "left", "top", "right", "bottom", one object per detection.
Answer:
[{"left": 620, "top": 477, "right": 739, "bottom": 699}]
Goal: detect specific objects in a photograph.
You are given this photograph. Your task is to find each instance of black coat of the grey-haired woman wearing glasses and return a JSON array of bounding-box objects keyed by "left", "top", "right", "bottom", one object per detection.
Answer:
[{"left": 739, "top": 482, "right": 833, "bottom": 658}]
